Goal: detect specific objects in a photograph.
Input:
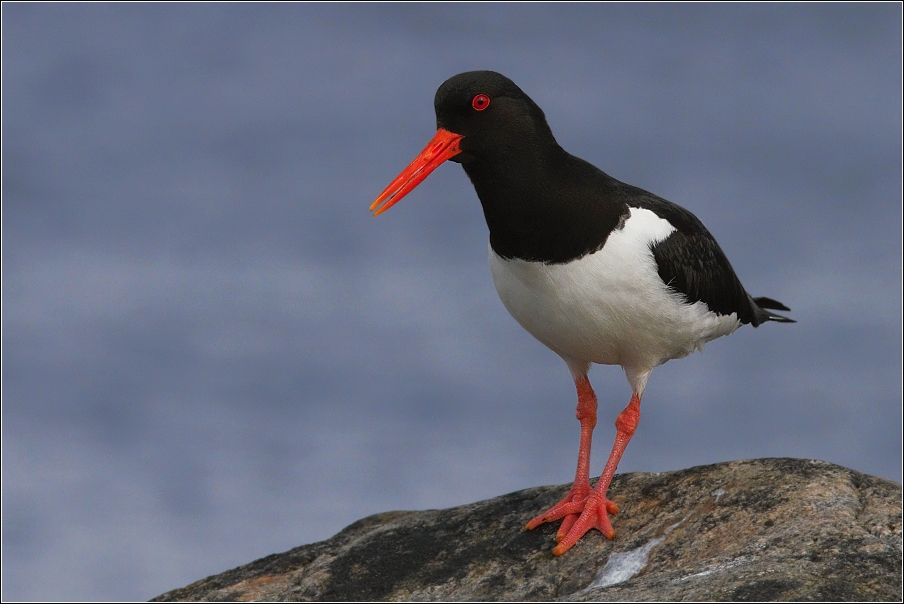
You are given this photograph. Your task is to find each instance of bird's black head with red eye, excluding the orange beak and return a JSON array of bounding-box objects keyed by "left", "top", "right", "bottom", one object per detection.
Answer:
[{"left": 433, "top": 71, "right": 558, "bottom": 164}]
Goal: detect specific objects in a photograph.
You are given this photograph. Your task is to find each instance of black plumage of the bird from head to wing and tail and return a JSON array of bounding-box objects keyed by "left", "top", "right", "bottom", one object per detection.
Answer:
[{"left": 435, "top": 72, "right": 793, "bottom": 326}]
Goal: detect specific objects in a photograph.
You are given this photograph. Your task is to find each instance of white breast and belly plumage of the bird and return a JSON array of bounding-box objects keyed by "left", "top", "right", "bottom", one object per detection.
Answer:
[{"left": 490, "top": 208, "right": 741, "bottom": 371}]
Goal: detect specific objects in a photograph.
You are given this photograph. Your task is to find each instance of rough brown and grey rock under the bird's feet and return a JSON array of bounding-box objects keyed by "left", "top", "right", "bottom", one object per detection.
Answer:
[{"left": 154, "top": 459, "right": 902, "bottom": 601}]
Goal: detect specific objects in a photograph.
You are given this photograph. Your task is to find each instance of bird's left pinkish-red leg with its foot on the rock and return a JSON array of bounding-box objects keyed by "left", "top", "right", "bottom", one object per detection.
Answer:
[{"left": 527, "top": 375, "right": 596, "bottom": 541}]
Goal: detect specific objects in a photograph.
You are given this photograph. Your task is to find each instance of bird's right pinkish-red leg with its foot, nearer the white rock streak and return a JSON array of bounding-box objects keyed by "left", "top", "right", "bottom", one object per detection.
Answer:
[{"left": 552, "top": 391, "right": 640, "bottom": 556}]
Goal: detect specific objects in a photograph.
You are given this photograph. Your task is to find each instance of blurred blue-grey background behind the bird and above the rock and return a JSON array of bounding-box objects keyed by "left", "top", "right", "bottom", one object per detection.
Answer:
[{"left": 2, "top": 3, "right": 902, "bottom": 600}]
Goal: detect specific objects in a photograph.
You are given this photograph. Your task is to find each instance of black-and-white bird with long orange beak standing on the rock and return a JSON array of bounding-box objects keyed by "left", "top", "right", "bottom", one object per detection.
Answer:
[{"left": 370, "top": 71, "right": 795, "bottom": 556}]
